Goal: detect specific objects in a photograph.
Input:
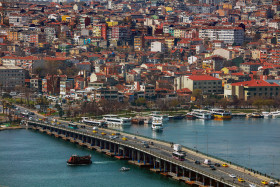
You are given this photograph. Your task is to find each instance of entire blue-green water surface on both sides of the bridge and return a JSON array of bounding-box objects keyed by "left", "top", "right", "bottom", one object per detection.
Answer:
[{"left": 0, "top": 118, "right": 280, "bottom": 186}]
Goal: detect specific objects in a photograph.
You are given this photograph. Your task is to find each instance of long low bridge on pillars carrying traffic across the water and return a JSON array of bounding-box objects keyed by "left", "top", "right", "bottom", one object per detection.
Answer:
[{"left": 25, "top": 120, "right": 278, "bottom": 187}]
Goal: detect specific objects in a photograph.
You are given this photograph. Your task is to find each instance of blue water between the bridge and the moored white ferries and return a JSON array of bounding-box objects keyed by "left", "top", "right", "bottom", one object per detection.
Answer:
[{"left": 122, "top": 118, "right": 280, "bottom": 178}]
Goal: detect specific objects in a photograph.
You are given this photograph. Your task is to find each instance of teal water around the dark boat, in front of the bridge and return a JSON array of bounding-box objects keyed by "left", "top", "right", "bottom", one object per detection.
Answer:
[{"left": 0, "top": 130, "right": 185, "bottom": 187}]
